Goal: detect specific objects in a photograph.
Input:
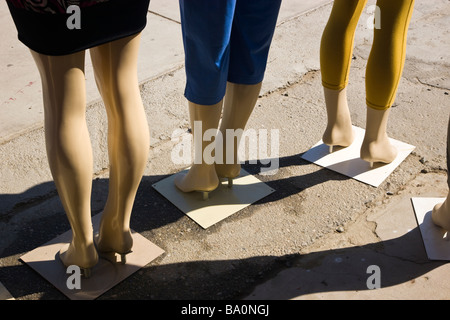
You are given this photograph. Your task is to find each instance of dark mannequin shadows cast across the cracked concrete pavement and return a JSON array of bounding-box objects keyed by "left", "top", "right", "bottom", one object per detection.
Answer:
[{"left": 0, "top": 155, "right": 444, "bottom": 300}]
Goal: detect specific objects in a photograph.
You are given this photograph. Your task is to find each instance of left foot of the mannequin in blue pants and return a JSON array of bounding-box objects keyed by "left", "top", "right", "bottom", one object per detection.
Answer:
[{"left": 175, "top": 164, "right": 219, "bottom": 200}]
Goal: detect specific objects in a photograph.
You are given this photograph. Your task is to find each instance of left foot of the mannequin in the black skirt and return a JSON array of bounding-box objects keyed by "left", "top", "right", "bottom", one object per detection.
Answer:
[{"left": 59, "top": 241, "right": 98, "bottom": 278}]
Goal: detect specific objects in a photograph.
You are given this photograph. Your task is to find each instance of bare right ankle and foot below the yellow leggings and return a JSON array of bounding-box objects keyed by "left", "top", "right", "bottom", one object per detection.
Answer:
[{"left": 360, "top": 107, "right": 398, "bottom": 164}]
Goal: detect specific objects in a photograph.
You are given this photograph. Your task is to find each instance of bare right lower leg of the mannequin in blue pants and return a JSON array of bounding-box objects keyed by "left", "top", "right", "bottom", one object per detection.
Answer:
[{"left": 216, "top": 82, "right": 262, "bottom": 181}]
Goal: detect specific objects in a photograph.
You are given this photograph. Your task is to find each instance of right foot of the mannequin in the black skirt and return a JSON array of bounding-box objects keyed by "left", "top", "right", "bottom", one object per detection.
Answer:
[{"left": 94, "top": 219, "right": 133, "bottom": 264}]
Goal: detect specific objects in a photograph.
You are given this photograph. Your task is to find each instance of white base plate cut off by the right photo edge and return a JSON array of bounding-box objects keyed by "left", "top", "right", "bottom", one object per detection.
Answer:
[{"left": 411, "top": 198, "right": 450, "bottom": 260}]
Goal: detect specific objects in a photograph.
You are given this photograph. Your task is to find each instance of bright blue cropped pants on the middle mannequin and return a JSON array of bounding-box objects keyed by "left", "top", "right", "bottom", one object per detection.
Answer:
[{"left": 179, "top": 0, "right": 281, "bottom": 105}]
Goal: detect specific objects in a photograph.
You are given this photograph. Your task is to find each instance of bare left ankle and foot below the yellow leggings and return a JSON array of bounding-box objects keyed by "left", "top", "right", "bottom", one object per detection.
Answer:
[{"left": 322, "top": 87, "right": 354, "bottom": 149}]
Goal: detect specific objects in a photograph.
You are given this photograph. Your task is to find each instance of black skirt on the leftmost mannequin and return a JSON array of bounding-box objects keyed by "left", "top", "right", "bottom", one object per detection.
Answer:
[{"left": 6, "top": 0, "right": 150, "bottom": 56}]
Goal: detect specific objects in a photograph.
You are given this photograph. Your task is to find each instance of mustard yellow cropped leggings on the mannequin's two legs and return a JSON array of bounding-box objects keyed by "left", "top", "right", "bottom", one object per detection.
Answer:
[{"left": 320, "top": 0, "right": 414, "bottom": 110}]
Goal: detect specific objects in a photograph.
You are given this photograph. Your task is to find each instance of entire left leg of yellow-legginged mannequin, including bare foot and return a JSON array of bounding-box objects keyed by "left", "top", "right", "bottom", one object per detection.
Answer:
[{"left": 320, "top": 0, "right": 367, "bottom": 150}]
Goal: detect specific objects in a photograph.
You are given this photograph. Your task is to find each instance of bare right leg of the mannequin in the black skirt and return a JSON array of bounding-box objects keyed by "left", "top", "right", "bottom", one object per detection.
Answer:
[{"left": 91, "top": 35, "right": 150, "bottom": 262}]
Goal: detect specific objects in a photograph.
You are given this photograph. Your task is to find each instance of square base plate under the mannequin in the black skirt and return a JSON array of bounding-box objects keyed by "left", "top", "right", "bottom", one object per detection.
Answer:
[{"left": 20, "top": 214, "right": 164, "bottom": 300}]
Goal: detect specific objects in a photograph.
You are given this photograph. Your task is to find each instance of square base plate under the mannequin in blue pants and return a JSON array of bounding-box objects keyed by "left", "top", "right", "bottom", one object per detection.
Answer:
[{"left": 153, "top": 169, "right": 275, "bottom": 229}]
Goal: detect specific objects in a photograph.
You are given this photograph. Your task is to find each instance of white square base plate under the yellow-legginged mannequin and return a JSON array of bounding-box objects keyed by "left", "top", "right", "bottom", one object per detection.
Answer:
[{"left": 302, "top": 126, "right": 415, "bottom": 187}]
